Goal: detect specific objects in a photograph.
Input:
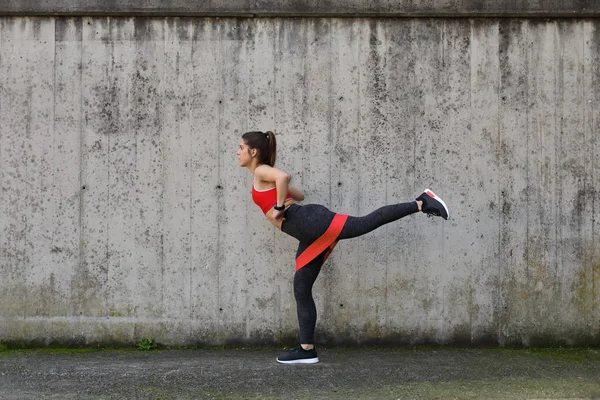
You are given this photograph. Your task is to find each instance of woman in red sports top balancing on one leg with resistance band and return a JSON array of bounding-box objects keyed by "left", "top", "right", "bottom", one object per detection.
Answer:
[{"left": 237, "top": 132, "right": 448, "bottom": 364}]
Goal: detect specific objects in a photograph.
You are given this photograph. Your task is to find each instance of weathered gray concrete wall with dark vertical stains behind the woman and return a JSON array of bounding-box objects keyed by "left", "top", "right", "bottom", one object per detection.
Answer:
[{"left": 0, "top": 16, "right": 600, "bottom": 345}]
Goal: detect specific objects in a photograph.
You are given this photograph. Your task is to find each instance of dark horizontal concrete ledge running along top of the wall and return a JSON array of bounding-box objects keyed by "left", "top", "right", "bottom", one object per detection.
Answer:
[{"left": 0, "top": 0, "right": 600, "bottom": 18}]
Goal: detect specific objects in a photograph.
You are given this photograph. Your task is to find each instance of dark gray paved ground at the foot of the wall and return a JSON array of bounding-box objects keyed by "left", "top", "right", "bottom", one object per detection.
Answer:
[{"left": 0, "top": 348, "right": 600, "bottom": 399}]
